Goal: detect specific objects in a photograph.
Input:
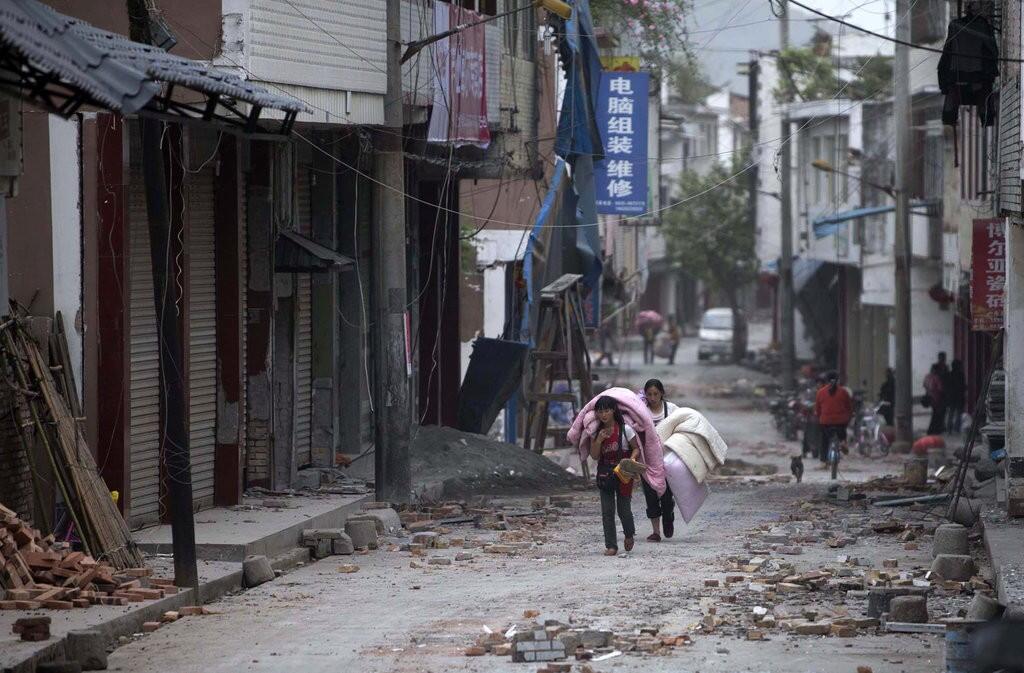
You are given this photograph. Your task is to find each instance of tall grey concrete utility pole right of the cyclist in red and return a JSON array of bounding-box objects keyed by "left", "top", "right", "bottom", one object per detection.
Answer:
[{"left": 893, "top": 0, "right": 913, "bottom": 447}]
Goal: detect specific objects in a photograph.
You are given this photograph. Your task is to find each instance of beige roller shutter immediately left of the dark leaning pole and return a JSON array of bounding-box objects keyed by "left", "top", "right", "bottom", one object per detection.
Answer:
[{"left": 128, "top": 167, "right": 160, "bottom": 528}]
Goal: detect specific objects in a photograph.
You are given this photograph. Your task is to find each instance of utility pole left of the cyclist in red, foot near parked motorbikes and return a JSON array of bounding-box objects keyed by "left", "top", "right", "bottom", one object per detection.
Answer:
[{"left": 778, "top": 0, "right": 797, "bottom": 390}]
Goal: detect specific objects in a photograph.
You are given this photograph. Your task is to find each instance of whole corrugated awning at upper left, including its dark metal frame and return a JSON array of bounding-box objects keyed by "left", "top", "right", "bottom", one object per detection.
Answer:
[{"left": 0, "top": 0, "right": 306, "bottom": 133}]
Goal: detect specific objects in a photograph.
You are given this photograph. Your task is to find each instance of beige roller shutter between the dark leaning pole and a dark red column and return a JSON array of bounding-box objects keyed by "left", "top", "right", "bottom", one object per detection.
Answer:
[{"left": 187, "top": 168, "right": 217, "bottom": 507}]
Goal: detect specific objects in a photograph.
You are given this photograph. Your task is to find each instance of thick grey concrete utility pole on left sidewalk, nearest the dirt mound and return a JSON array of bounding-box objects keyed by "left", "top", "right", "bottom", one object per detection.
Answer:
[{"left": 373, "top": 0, "right": 413, "bottom": 502}]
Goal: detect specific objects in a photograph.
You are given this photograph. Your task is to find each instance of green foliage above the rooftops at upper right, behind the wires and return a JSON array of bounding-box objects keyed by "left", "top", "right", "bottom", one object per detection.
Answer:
[{"left": 775, "top": 47, "right": 893, "bottom": 101}]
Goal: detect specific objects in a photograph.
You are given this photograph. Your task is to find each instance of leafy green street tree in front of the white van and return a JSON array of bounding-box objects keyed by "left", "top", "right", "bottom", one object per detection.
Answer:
[{"left": 663, "top": 153, "right": 759, "bottom": 359}]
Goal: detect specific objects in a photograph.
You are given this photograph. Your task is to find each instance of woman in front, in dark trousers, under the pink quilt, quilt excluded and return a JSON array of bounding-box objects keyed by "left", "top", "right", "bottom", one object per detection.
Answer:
[{"left": 590, "top": 395, "right": 640, "bottom": 556}]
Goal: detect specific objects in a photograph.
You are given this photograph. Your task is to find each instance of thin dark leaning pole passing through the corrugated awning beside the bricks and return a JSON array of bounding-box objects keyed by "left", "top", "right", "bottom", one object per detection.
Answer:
[{"left": 127, "top": 0, "right": 199, "bottom": 590}]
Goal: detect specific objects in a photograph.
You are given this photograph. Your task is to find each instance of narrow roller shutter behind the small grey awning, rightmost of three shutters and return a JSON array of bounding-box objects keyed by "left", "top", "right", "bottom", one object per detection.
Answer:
[{"left": 295, "top": 165, "right": 313, "bottom": 467}]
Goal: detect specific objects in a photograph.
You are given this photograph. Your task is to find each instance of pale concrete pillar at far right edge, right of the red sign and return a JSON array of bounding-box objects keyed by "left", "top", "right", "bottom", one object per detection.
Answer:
[{"left": 1004, "top": 220, "right": 1024, "bottom": 516}]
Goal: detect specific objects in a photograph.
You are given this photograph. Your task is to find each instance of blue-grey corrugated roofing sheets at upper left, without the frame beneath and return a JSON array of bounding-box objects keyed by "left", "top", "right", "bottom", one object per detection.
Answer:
[{"left": 0, "top": 0, "right": 306, "bottom": 122}]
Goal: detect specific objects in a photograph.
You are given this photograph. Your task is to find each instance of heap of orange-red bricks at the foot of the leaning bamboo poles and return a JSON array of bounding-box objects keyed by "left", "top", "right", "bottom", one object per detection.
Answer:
[{"left": 0, "top": 505, "right": 172, "bottom": 609}]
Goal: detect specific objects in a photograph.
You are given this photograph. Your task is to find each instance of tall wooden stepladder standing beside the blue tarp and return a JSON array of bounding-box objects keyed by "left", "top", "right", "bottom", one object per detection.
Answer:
[{"left": 523, "top": 274, "right": 593, "bottom": 476}]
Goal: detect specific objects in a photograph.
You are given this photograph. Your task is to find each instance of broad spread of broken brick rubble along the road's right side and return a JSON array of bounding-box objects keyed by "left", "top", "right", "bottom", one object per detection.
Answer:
[{"left": 695, "top": 501, "right": 992, "bottom": 640}]
